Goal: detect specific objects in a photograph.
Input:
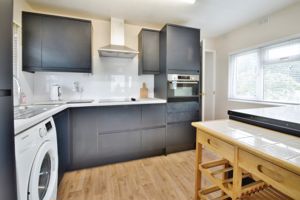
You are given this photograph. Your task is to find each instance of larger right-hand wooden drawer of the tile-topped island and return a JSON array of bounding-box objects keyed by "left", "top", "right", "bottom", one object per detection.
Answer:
[{"left": 239, "top": 150, "right": 300, "bottom": 199}]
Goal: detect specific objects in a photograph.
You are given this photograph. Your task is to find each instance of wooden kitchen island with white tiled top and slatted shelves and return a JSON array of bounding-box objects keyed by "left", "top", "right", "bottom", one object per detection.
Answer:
[{"left": 192, "top": 120, "right": 300, "bottom": 200}]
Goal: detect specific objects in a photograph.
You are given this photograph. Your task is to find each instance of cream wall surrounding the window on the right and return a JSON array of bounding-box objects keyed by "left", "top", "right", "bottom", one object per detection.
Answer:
[{"left": 215, "top": 3, "right": 300, "bottom": 119}]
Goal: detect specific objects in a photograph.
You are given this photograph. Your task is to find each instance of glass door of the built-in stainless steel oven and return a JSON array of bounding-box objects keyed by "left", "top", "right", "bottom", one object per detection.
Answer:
[{"left": 168, "top": 81, "right": 199, "bottom": 100}]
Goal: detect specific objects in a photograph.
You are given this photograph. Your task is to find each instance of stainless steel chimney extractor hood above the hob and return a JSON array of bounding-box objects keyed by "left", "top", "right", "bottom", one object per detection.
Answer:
[{"left": 98, "top": 18, "right": 139, "bottom": 58}]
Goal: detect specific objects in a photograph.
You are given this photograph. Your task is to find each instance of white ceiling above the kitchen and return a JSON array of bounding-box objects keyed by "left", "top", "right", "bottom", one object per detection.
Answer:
[{"left": 27, "top": 0, "right": 299, "bottom": 37}]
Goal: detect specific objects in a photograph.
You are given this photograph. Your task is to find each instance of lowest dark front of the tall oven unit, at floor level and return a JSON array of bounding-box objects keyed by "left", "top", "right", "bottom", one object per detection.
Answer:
[{"left": 166, "top": 122, "right": 196, "bottom": 153}]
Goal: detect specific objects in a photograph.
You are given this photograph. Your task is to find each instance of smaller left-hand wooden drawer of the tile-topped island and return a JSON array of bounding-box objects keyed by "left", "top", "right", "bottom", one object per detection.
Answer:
[{"left": 198, "top": 132, "right": 234, "bottom": 162}]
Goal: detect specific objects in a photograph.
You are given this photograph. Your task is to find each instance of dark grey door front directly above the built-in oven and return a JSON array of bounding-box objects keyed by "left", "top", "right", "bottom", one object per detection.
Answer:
[{"left": 167, "top": 25, "right": 200, "bottom": 73}]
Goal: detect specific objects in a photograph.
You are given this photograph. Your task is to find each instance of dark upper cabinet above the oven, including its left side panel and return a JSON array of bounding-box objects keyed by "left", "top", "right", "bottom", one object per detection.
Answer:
[{"left": 160, "top": 24, "right": 201, "bottom": 74}]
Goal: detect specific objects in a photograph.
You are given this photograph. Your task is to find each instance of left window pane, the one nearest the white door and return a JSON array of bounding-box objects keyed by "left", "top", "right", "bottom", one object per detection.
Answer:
[{"left": 235, "top": 52, "right": 259, "bottom": 99}]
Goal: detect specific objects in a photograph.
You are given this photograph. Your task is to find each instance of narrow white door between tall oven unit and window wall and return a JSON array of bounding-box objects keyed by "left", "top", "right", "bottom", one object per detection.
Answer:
[{"left": 203, "top": 51, "right": 216, "bottom": 121}]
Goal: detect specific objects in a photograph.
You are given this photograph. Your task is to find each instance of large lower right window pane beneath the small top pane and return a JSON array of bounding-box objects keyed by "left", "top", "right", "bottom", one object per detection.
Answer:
[{"left": 264, "top": 61, "right": 300, "bottom": 103}]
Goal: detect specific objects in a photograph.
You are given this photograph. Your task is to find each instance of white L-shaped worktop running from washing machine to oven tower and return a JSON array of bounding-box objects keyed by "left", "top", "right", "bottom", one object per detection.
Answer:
[{"left": 14, "top": 98, "right": 167, "bottom": 135}]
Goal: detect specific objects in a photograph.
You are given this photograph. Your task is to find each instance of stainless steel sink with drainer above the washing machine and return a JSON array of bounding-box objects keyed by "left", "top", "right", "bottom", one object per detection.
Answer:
[{"left": 14, "top": 105, "right": 59, "bottom": 120}]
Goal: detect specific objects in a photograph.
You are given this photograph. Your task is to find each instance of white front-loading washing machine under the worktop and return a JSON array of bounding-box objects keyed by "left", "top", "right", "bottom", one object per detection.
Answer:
[{"left": 15, "top": 118, "right": 58, "bottom": 200}]
